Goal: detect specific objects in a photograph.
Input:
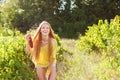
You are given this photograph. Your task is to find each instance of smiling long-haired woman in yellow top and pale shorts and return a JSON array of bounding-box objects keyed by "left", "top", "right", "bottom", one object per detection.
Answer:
[{"left": 26, "top": 21, "right": 57, "bottom": 80}]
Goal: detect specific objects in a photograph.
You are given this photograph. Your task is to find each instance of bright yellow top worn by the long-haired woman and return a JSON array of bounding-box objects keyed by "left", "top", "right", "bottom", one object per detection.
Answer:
[{"left": 35, "top": 39, "right": 57, "bottom": 67}]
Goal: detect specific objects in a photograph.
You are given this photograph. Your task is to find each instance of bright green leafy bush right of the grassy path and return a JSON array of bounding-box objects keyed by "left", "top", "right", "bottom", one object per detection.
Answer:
[{"left": 78, "top": 16, "right": 120, "bottom": 54}]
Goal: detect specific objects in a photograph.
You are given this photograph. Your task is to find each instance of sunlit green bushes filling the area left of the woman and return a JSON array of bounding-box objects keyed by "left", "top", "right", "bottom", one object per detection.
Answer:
[{"left": 0, "top": 28, "right": 35, "bottom": 80}]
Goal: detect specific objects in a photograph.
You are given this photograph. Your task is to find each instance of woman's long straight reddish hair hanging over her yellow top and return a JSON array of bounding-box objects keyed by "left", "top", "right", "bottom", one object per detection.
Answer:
[{"left": 32, "top": 21, "right": 55, "bottom": 60}]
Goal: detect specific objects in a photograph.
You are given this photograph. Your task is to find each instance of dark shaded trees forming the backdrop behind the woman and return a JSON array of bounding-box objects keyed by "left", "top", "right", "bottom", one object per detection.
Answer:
[{"left": 0, "top": 0, "right": 120, "bottom": 38}]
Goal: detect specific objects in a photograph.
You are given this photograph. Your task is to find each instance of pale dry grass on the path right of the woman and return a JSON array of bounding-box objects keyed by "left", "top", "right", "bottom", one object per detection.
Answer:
[{"left": 57, "top": 39, "right": 120, "bottom": 80}]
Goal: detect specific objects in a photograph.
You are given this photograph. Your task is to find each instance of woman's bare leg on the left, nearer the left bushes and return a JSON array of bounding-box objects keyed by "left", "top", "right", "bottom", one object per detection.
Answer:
[{"left": 36, "top": 67, "right": 46, "bottom": 80}]
